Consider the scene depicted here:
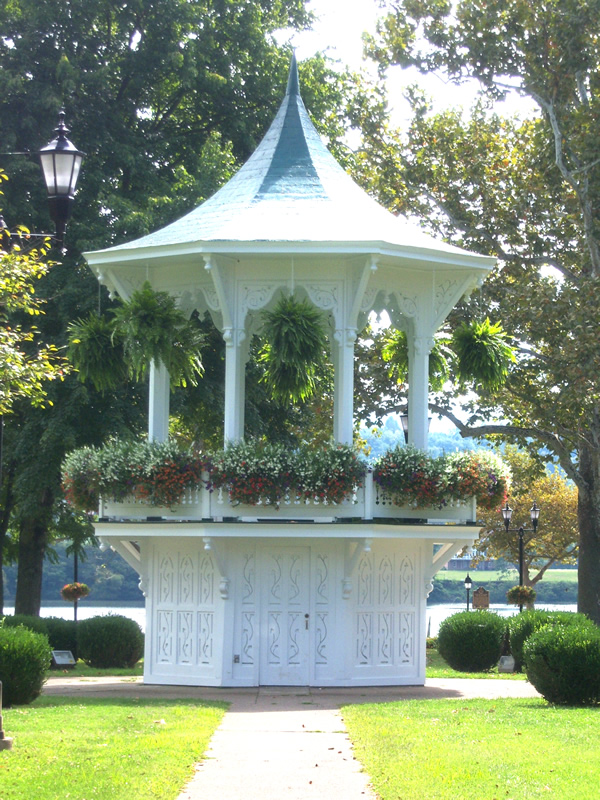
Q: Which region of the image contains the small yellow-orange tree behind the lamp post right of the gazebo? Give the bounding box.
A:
[474,446,578,586]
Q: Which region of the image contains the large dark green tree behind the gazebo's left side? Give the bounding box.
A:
[0,0,370,614]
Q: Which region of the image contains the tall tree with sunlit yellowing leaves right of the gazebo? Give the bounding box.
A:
[358,0,600,623]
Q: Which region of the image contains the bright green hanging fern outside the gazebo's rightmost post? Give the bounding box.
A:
[452,318,516,391]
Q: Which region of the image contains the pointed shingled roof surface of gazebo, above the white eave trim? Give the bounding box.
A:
[88,56,482,255]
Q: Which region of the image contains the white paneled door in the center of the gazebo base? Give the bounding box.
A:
[260,545,312,686]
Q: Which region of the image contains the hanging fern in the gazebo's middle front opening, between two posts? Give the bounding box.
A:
[258,296,327,403]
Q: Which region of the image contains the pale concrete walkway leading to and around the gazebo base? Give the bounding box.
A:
[44,677,538,800]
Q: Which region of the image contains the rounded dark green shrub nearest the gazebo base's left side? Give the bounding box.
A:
[77,614,144,668]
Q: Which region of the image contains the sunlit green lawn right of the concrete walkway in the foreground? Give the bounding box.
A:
[342,699,600,800]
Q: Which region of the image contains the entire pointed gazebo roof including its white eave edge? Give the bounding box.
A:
[85,57,495,273]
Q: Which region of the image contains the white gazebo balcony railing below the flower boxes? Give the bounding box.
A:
[99,472,475,523]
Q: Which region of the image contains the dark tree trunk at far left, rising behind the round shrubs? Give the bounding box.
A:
[15,514,48,617]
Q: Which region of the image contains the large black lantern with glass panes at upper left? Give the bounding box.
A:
[38,109,85,244]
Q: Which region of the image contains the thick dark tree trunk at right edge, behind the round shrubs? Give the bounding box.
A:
[577,448,600,625]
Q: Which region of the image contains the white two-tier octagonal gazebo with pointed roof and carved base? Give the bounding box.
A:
[86,54,495,686]
